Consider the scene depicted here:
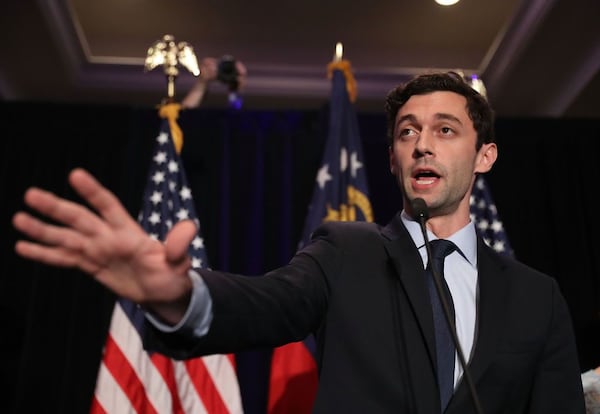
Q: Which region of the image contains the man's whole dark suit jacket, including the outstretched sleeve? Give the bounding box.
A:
[146,216,585,414]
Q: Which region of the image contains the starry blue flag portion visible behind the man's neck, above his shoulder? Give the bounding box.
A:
[469,175,514,256]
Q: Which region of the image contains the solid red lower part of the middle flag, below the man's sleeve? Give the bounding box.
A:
[268,342,318,414]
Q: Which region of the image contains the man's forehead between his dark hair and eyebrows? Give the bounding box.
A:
[396,91,469,123]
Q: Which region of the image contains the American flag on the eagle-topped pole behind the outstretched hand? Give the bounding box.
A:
[90,104,243,414]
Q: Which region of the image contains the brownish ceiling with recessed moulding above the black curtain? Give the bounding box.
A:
[0,0,600,117]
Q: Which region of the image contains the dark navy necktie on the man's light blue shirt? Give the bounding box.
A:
[426,239,457,412]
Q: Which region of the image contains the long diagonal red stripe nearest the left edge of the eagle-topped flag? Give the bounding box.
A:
[104,335,156,414]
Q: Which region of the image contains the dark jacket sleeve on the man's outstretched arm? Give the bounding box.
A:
[144,233,339,359]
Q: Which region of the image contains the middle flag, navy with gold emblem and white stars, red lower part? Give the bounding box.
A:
[268,60,373,414]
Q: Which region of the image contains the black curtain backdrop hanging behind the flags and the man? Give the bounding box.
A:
[0,103,600,414]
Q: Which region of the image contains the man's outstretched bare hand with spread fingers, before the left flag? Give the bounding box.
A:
[13,169,196,324]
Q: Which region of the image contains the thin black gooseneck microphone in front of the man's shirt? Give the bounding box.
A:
[410,197,483,414]
